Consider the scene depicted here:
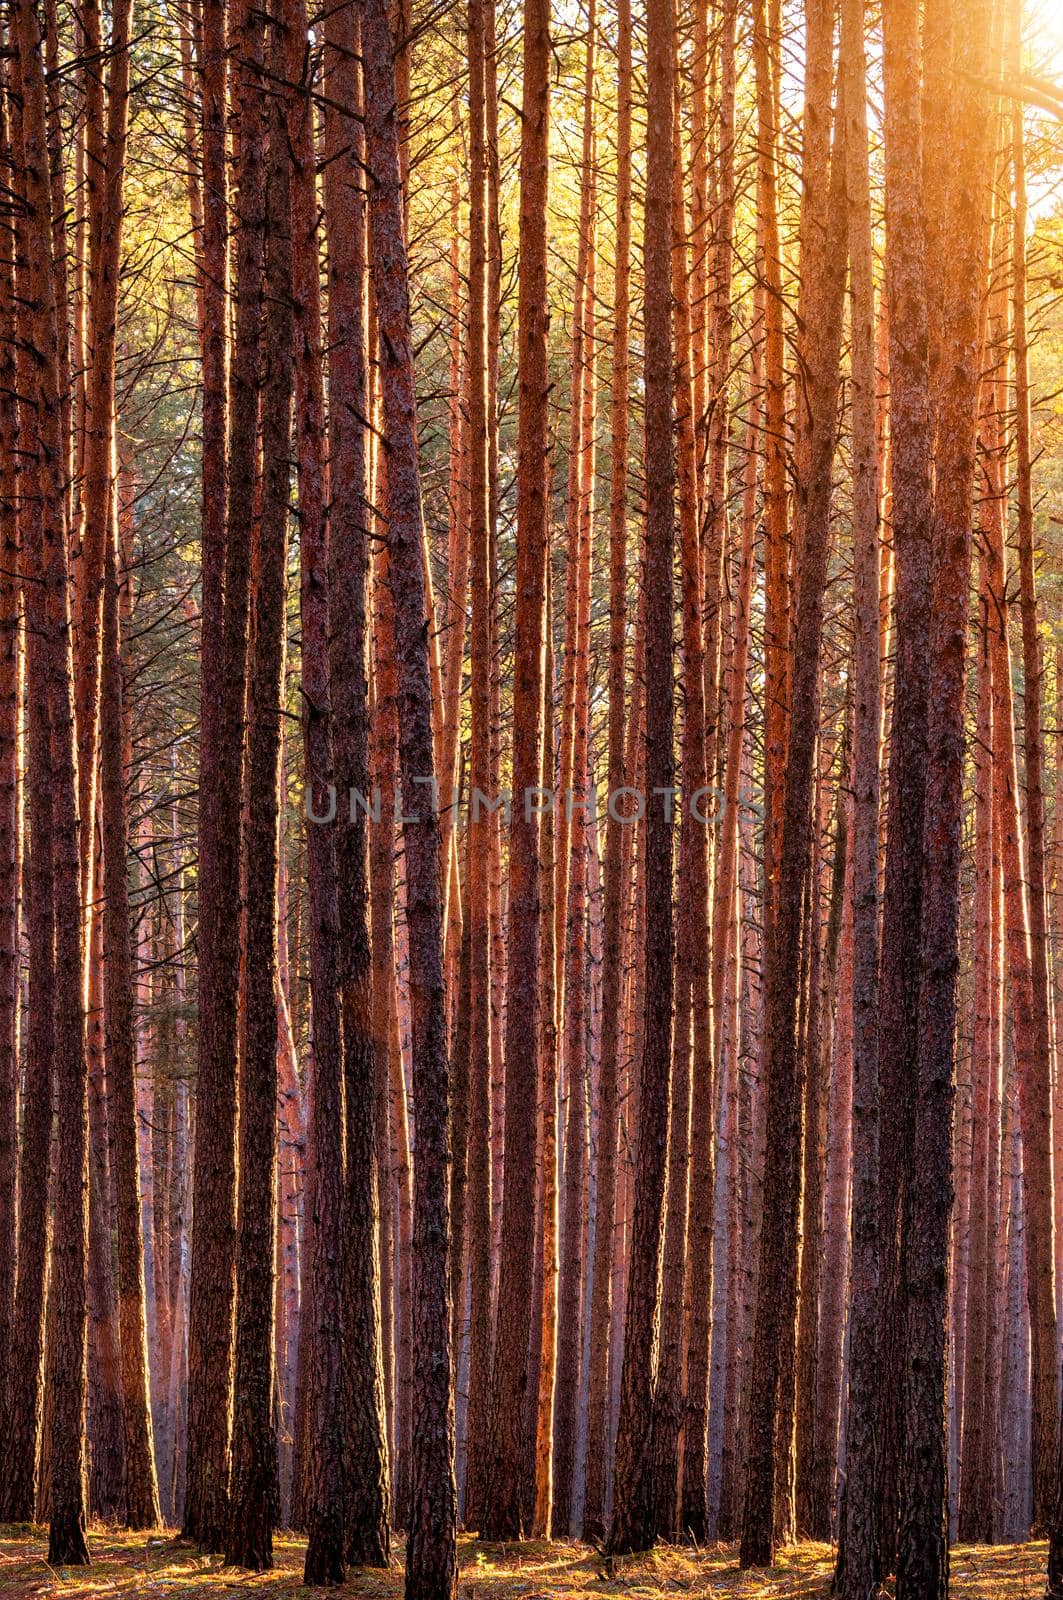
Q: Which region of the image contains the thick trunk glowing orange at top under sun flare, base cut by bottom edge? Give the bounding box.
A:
[890,0,988,1600]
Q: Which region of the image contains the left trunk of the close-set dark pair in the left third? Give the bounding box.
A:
[184,0,266,1550]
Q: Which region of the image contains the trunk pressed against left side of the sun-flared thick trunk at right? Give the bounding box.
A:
[877,0,932,1573]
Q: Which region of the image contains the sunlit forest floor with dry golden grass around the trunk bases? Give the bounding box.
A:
[0,1526,1047,1600]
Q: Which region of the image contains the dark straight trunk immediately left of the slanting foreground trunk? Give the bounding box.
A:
[325,5,394,1566]
